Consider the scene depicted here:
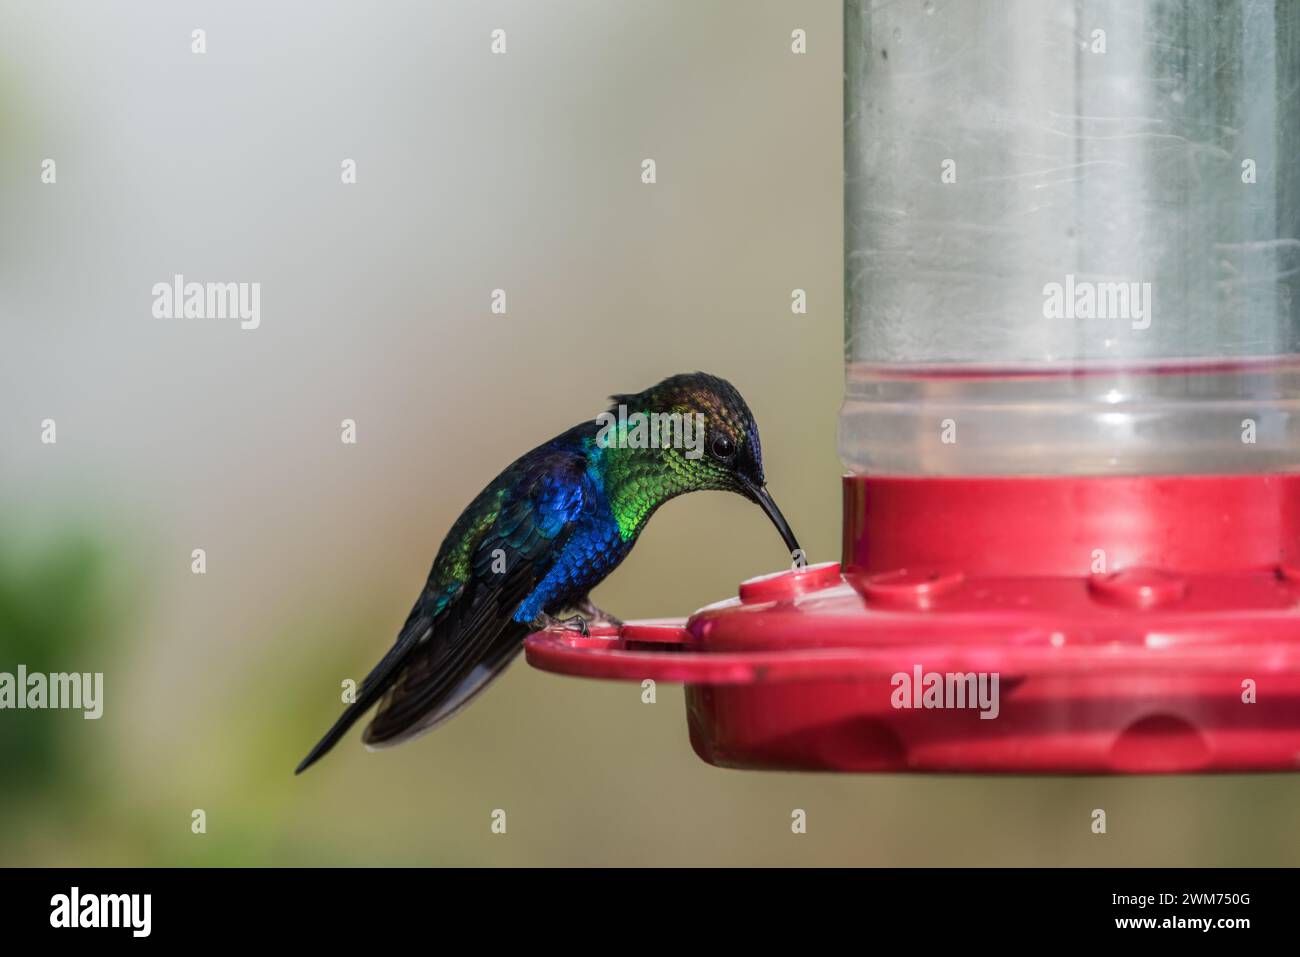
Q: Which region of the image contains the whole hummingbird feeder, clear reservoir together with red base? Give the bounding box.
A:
[527,0,1300,772]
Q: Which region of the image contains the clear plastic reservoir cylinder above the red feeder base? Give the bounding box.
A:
[841,0,1300,475]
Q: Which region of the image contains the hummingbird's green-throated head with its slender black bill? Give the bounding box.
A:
[607,372,800,554]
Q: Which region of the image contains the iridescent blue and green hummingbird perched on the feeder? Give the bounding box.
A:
[295,372,802,774]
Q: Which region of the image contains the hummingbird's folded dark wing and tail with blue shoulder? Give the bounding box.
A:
[299,446,592,771]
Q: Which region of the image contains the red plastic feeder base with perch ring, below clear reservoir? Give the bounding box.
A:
[525,475,1300,774]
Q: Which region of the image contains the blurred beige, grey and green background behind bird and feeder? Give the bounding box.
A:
[0,0,1300,865]
